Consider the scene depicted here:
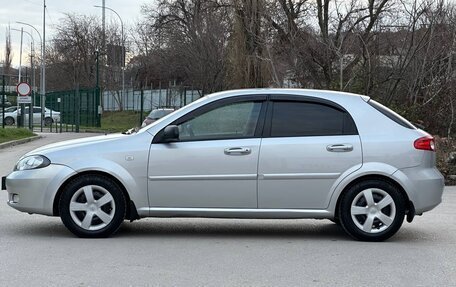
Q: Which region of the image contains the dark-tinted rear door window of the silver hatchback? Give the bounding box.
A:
[271,101,357,137]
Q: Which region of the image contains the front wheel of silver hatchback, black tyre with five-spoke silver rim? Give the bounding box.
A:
[59,175,126,238]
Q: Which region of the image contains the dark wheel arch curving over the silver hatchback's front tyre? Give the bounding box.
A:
[52,170,140,221]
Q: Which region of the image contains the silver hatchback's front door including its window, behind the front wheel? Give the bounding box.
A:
[148,96,265,208]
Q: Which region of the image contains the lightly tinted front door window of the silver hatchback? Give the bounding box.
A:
[178,101,262,141]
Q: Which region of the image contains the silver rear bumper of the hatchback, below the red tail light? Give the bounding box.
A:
[392,167,445,214]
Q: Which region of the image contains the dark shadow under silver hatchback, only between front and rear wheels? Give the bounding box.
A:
[115,218,352,241]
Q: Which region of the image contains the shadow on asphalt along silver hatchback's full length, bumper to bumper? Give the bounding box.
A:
[8,218,436,243]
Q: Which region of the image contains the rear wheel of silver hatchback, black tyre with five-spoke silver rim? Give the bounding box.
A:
[339,180,406,241]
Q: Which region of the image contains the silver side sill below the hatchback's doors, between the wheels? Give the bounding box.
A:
[138,207,333,219]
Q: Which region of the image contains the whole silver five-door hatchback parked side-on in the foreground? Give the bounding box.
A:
[4,89,444,241]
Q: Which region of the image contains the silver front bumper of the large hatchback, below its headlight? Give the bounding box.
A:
[5,164,76,215]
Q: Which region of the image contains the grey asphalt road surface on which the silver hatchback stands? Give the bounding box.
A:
[0,133,456,286]
